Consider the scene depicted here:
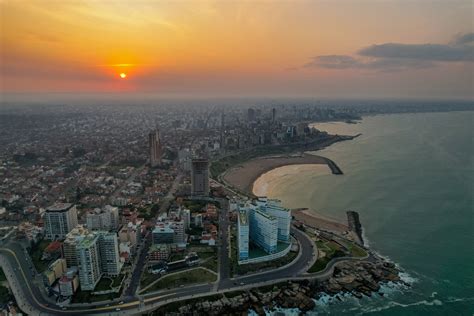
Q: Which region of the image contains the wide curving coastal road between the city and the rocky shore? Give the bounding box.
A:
[0,223,362,315]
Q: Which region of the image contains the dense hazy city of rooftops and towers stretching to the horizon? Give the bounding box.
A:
[0,98,465,314]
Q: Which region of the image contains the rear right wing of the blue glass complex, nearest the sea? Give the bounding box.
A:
[256,197,291,242]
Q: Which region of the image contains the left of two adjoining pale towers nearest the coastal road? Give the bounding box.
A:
[76,234,102,291]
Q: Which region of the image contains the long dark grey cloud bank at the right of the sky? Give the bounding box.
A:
[303,33,474,71]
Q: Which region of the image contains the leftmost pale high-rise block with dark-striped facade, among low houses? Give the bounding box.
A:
[44,203,77,240]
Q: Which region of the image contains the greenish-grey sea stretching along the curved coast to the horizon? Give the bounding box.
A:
[255,112,474,315]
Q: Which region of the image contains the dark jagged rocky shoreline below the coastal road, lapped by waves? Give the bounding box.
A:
[154,257,409,315]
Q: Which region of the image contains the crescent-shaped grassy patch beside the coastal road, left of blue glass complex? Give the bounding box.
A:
[147,268,217,292]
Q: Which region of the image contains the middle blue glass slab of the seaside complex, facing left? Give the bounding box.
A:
[249,207,278,253]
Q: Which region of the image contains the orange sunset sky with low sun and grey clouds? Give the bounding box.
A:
[0,0,474,99]
